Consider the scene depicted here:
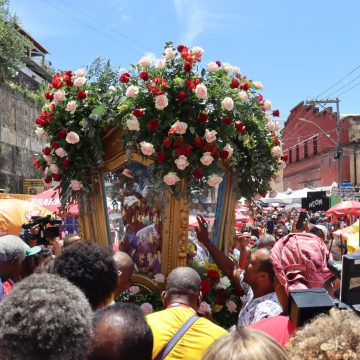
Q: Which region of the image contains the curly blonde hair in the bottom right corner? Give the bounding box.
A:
[286,309,360,360]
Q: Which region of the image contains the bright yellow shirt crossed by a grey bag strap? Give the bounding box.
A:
[146,306,227,360]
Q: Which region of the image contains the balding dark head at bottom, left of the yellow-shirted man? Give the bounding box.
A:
[89,303,153,360]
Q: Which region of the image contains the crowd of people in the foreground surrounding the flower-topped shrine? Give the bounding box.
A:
[0,205,360,360]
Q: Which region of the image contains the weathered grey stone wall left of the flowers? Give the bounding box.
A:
[0,84,42,193]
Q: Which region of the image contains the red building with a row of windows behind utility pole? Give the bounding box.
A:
[282,102,360,190]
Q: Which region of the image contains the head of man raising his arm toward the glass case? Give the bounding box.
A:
[244,248,275,295]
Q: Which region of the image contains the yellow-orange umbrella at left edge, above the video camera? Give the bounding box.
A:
[0,198,52,236]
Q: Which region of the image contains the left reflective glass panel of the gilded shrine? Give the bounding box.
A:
[104,162,162,275]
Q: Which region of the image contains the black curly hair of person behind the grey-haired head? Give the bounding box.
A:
[54,242,118,309]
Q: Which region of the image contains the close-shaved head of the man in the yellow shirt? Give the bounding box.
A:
[162,267,202,310]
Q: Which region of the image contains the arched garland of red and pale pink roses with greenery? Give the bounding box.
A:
[34,43,285,210]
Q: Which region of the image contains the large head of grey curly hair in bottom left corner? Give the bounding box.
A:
[0,273,92,360]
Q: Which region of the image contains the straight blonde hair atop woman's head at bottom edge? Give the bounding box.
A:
[203,328,289,360]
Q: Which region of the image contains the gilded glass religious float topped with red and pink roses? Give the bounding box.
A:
[34,43,285,326]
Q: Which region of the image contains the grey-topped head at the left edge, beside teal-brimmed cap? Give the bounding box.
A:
[0,235,25,281]
